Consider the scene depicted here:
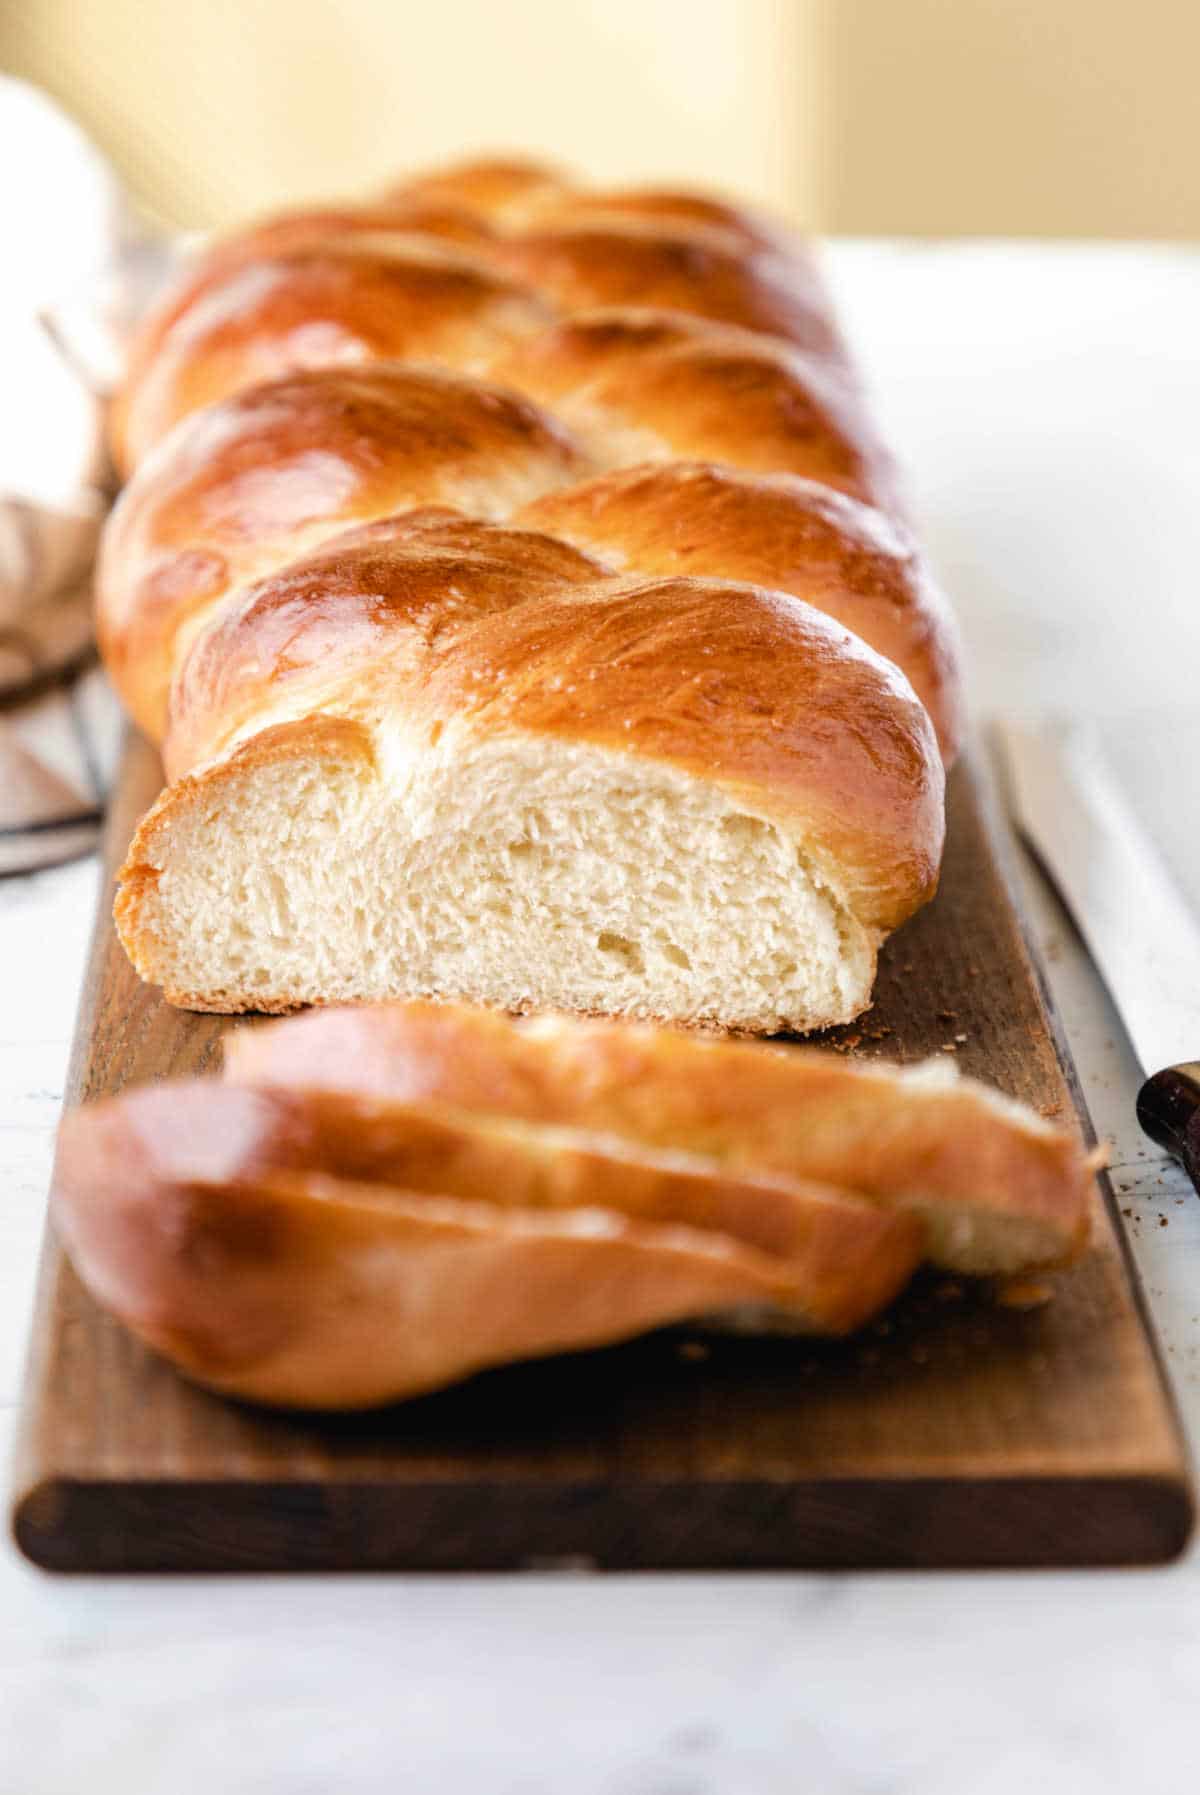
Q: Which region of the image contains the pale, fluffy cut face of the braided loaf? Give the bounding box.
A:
[115,718,879,1032]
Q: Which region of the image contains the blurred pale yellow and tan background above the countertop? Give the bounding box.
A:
[0,0,1200,237]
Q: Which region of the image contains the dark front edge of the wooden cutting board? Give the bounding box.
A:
[13,1475,1193,1572]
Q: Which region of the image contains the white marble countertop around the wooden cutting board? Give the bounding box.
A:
[0,244,1200,1795]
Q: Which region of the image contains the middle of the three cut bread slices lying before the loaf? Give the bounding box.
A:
[56,1079,922,1332]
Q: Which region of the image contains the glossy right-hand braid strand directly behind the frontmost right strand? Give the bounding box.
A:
[515,461,963,766]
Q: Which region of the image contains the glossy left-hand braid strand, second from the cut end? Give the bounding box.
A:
[97,366,587,738]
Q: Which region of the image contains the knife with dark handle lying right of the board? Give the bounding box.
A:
[1001,723,1200,1192]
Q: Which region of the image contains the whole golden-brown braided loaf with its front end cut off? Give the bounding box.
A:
[99,163,961,1030]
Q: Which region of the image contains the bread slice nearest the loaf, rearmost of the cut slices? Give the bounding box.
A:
[226,1003,1096,1274]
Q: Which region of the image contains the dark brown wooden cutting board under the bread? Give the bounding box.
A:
[13,743,1193,1571]
